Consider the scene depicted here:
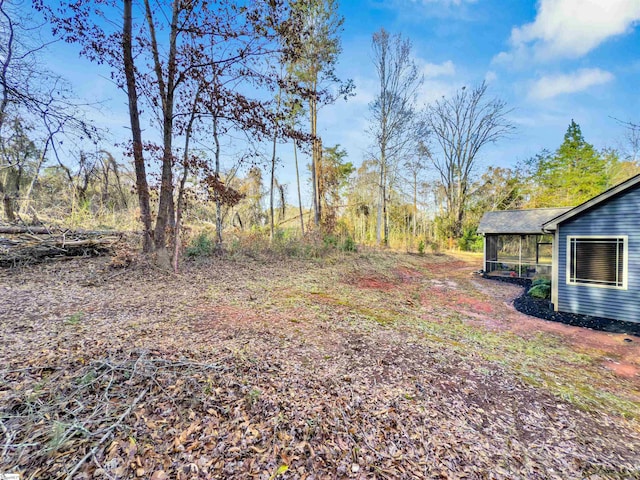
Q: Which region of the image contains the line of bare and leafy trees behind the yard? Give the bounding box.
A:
[0,0,638,265]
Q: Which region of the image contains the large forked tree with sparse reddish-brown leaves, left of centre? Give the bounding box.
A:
[42,0,298,266]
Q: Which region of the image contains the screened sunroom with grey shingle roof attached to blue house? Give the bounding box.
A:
[478,208,570,278]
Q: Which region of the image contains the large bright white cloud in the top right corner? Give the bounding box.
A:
[494,0,640,62]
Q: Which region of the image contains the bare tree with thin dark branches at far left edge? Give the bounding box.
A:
[0,0,100,221]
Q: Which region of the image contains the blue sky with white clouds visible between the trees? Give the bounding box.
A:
[31,0,640,202]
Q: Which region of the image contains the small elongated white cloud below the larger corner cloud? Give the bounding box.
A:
[529,68,614,100]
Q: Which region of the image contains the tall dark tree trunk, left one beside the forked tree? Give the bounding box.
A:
[122,0,153,253]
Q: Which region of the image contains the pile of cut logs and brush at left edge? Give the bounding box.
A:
[0,225,123,267]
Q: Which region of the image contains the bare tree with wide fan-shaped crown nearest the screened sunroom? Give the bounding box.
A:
[425,82,515,242]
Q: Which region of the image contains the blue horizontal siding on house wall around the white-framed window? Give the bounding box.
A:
[556,187,640,322]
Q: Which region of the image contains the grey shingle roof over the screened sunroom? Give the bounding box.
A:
[478,207,572,235]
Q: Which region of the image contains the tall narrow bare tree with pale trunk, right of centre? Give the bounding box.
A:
[369,29,423,244]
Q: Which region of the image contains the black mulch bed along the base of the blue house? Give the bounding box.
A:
[484,275,640,340]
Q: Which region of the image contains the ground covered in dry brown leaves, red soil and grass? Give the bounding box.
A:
[0,252,640,480]
